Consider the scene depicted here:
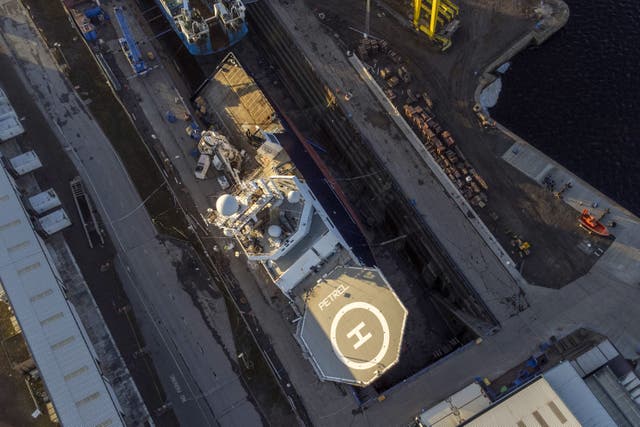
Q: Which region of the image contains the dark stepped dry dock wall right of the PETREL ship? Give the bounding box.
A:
[249,2,498,334]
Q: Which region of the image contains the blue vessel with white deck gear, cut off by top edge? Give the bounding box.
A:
[155,0,248,55]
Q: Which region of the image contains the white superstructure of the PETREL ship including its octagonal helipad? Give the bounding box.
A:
[210,171,407,386]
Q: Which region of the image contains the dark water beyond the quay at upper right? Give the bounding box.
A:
[491,0,640,215]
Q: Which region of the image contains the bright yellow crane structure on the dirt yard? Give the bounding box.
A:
[413,0,460,51]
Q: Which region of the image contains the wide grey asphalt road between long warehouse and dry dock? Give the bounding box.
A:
[0,0,262,426]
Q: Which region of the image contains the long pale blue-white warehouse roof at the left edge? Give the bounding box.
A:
[0,168,124,426]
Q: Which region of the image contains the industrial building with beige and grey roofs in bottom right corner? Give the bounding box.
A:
[416,340,640,427]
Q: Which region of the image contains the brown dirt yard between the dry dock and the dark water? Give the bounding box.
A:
[307,0,611,288]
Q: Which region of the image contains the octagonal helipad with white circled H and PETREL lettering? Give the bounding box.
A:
[300,266,407,386]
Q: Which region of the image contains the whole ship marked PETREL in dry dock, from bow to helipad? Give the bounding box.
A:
[185,54,409,389]
